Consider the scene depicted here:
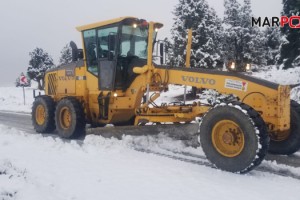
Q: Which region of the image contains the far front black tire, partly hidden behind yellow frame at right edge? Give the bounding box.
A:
[269,100,300,155]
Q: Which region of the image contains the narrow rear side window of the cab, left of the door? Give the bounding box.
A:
[83,29,98,75]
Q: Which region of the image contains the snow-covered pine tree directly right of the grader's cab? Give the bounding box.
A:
[171,0,222,68]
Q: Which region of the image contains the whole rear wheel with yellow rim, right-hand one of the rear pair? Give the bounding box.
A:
[55,98,86,139]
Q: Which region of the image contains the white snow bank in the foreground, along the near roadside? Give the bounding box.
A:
[0,125,300,200]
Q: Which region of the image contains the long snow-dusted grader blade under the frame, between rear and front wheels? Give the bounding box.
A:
[87,123,199,144]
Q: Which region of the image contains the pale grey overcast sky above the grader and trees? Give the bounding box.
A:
[0,0,282,86]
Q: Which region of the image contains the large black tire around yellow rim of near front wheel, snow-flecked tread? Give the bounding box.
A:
[200,102,270,173]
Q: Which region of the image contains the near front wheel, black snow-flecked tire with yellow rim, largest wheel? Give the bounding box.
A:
[200,102,269,173]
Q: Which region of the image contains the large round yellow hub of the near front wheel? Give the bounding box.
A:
[212,120,245,157]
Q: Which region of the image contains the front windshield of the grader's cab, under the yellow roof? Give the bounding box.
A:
[120,25,156,59]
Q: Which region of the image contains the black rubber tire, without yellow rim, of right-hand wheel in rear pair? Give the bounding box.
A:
[55,97,86,139]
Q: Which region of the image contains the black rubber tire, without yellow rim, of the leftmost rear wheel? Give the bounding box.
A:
[31,96,55,133]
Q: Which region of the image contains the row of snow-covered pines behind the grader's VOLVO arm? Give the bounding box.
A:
[166,0,300,69]
